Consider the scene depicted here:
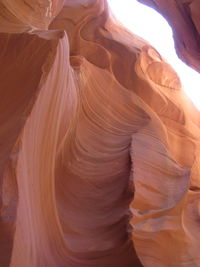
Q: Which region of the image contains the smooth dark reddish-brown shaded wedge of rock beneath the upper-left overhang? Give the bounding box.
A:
[0,29,59,197]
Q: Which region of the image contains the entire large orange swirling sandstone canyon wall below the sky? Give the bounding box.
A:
[0,0,200,267]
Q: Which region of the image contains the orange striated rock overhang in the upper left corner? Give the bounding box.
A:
[0,0,64,33]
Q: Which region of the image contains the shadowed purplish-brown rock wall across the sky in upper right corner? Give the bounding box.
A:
[137,0,200,72]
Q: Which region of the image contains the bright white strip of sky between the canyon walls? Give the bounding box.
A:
[108,0,200,110]
